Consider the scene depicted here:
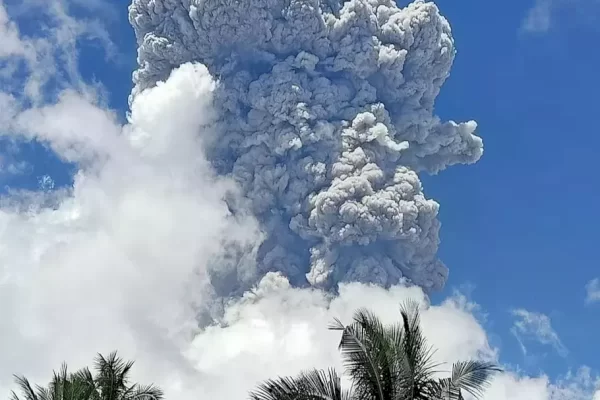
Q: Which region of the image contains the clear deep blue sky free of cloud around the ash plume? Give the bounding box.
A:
[1,0,600,398]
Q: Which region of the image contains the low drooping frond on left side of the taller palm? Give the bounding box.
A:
[250,369,349,400]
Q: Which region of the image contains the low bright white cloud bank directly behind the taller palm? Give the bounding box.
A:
[177,276,576,400]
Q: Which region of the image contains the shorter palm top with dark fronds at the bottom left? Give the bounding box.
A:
[11,352,163,400]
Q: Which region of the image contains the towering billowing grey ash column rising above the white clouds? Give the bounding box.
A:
[129,0,483,293]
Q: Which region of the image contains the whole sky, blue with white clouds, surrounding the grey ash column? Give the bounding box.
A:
[0,0,600,400]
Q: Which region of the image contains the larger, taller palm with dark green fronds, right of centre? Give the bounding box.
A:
[250,301,500,400]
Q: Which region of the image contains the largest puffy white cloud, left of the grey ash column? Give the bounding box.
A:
[0,61,258,396]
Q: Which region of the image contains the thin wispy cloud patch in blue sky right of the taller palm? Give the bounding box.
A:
[511,309,568,356]
